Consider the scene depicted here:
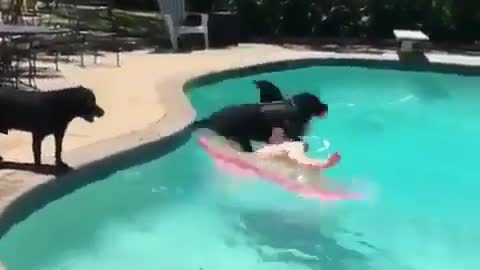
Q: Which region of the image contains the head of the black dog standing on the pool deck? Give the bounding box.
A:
[73,86,105,122]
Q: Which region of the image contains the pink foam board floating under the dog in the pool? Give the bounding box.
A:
[199,135,363,201]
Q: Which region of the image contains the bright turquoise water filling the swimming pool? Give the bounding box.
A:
[0,66,480,270]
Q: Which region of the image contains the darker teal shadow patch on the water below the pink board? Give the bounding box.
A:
[232,210,369,270]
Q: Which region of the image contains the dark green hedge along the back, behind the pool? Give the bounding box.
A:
[111,0,480,42]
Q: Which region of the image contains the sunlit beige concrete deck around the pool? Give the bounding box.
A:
[0,44,480,269]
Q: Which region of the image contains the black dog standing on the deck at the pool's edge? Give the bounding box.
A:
[0,86,104,166]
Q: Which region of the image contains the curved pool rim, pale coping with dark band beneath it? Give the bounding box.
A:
[0,48,480,269]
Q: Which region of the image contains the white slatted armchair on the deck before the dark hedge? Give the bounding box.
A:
[157,0,209,50]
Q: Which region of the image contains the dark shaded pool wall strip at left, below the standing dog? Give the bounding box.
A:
[0,126,192,238]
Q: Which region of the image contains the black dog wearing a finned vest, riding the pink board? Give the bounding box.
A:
[194,81,328,152]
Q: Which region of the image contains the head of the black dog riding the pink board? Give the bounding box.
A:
[292,93,328,120]
